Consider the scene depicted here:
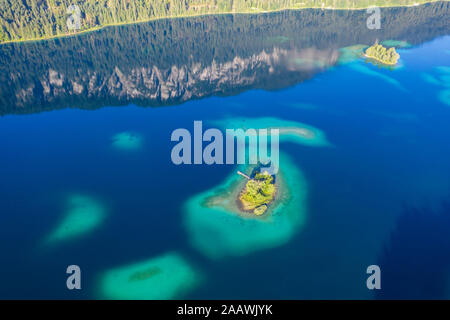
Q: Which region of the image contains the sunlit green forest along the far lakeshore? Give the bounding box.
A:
[0,0,437,42]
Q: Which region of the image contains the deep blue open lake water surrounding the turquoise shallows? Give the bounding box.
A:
[0,12,450,299]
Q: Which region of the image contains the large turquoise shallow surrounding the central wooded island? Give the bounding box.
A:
[183,154,307,259]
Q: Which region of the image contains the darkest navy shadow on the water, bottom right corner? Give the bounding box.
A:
[376,200,450,299]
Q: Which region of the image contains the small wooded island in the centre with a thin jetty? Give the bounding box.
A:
[238,171,276,216]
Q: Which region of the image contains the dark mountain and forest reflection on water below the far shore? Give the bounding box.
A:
[0,2,449,115]
